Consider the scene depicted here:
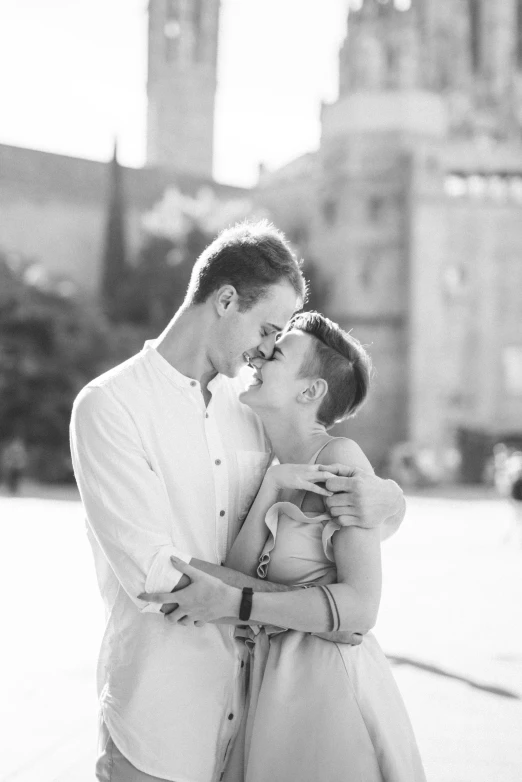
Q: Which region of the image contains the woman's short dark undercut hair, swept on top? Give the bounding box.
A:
[288,312,372,428]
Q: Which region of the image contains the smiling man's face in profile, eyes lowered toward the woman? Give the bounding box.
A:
[215,282,301,377]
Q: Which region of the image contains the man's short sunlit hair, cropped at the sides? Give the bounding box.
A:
[186,220,307,312]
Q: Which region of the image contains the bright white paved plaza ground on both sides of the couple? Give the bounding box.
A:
[0,487,522,782]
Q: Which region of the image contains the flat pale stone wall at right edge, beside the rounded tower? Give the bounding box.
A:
[410,149,522,447]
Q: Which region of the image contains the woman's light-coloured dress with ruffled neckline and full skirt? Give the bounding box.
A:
[230,454,425,782]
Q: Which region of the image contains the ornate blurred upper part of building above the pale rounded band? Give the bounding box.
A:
[340,0,522,139]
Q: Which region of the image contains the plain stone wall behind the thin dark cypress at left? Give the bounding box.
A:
[0,145,245,295]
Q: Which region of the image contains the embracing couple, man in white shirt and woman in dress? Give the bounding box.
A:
[71,222,425,782]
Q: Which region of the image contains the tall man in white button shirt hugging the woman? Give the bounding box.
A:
[71,222,404,782]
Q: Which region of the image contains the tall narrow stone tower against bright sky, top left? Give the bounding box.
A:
[147,0,219,178]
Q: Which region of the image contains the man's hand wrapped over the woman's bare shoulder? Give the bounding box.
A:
[325,464,404,528]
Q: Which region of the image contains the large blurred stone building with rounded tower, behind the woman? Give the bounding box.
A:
[257,0,522,464]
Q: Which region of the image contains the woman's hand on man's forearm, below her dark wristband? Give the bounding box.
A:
[138,557,241,627]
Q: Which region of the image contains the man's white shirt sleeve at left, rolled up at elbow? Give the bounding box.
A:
[70,386,191,612]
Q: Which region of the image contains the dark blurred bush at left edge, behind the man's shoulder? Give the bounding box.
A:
[0,258,110,481]
